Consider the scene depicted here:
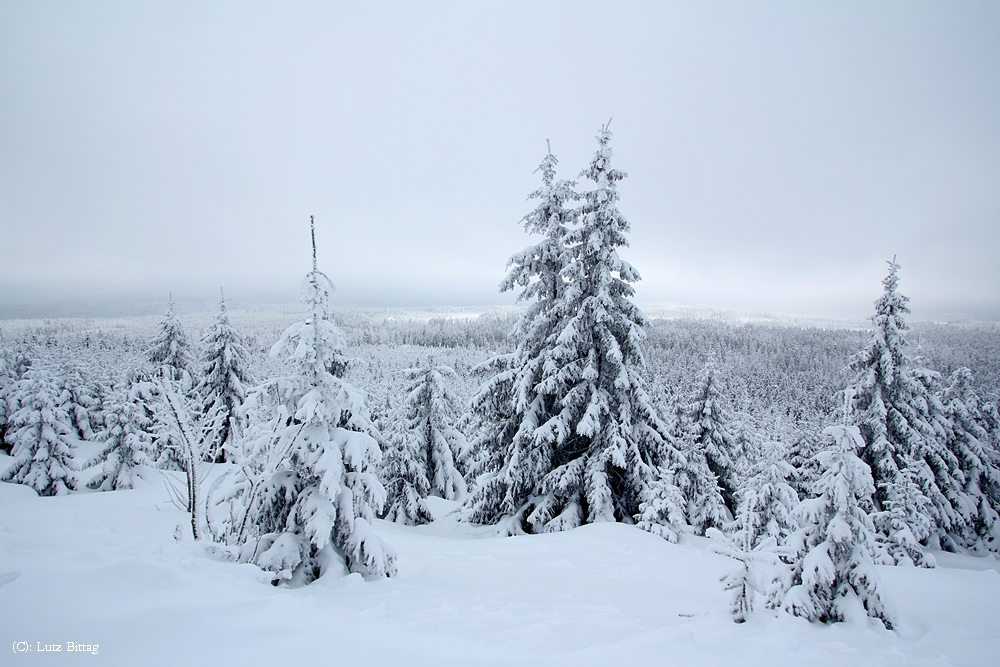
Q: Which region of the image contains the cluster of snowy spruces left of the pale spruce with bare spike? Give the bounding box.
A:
[0,290,252,495]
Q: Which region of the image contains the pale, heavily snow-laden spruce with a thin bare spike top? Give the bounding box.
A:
[210,220,396,583]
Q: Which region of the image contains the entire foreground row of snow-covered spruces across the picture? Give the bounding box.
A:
[0,126,1000,627]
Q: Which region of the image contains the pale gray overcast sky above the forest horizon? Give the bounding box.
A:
[0,0,1000,320]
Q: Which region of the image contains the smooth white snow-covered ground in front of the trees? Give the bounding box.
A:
[0,454,1000,667]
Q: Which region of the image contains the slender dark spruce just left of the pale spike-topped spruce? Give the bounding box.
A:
[197,290,252,463]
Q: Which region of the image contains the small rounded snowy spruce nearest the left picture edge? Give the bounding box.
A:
[3,367,78,496]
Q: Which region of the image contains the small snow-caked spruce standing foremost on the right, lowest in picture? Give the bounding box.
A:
[781,426,896,630]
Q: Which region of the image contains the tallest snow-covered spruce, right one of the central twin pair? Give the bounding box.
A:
[469,126,684,539]
